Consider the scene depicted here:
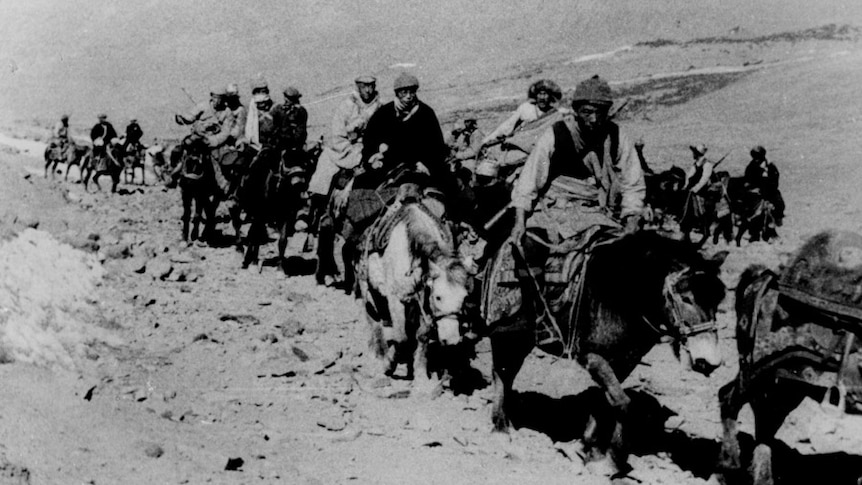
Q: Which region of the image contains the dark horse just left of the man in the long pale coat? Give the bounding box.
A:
[238,148,309,272]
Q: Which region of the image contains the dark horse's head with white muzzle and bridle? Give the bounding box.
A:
[663,251,727,375]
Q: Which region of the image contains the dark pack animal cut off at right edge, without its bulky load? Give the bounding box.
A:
[717,246,862,485]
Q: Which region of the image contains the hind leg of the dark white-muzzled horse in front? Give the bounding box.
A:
[490,313,536,432]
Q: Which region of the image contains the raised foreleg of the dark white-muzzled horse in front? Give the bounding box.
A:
[584,353,631,475]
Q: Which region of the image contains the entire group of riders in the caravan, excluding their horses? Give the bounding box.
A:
[45,73,784,292]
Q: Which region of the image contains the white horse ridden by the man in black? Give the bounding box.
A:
[357,194,480,393]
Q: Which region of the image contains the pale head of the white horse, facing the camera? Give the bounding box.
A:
[423,257,470,345]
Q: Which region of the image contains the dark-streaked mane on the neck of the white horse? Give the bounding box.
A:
[404,203,468,285]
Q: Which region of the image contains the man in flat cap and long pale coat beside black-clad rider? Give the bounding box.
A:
[308,75,382,283]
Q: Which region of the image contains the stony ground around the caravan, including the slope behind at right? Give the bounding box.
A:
[0,15,862,484]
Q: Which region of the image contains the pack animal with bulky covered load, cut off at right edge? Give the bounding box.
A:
[718,231,862,485]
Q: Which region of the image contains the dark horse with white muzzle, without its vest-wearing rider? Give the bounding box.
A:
[483,231,727,470]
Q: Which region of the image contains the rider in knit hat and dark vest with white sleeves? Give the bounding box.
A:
[512,76,646,243]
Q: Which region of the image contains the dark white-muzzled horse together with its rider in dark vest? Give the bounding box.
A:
[481,76,726,476]
